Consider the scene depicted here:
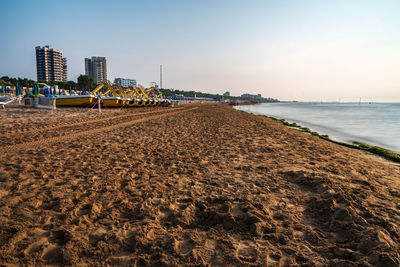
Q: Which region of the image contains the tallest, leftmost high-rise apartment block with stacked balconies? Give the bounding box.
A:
[36,45,67,82]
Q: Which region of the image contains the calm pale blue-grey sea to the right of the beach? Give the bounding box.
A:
[236,102,400,152]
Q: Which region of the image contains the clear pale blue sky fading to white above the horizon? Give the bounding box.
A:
[0,0,400,101]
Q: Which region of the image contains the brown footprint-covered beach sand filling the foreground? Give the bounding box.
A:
[0,105,400,266]
